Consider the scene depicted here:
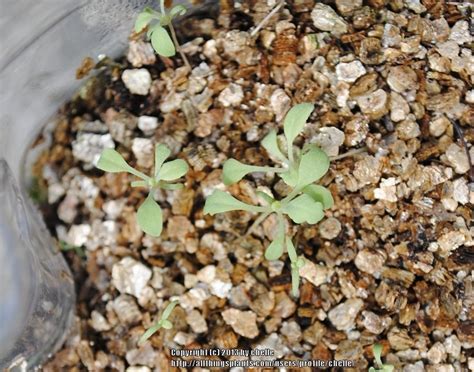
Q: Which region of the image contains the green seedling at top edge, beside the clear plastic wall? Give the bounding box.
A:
[135,0,191,68]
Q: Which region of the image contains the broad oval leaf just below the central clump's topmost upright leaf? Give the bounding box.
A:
[296,146,329,188]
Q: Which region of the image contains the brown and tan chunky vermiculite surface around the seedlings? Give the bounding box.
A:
[32,0,474,372]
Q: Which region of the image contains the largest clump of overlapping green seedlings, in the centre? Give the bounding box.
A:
[204,103,334,296]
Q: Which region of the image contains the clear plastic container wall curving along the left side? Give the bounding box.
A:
[0,0,216,370]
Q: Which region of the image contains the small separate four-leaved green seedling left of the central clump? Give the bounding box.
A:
[97,144,189,237]
